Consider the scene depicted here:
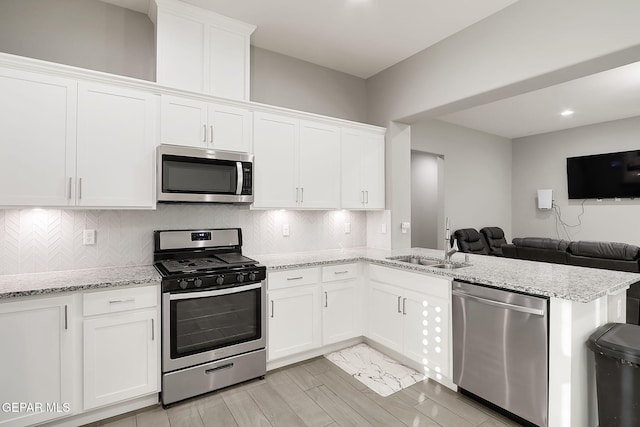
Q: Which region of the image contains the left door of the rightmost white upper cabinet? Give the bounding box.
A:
[340,129,365,209]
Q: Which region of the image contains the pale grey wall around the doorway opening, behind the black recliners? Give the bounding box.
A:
[411,120,512,242]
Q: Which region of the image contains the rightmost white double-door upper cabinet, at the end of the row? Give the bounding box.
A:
[341,128,385,209]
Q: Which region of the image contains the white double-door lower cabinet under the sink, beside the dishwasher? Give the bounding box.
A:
[367,265,451,379]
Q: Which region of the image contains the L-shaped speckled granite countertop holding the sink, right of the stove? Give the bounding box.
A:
[250,248,640,302]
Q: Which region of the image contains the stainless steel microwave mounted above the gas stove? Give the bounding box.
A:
[156,145,253,203]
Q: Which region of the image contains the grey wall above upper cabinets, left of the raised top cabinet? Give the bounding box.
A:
[0,0,156,81]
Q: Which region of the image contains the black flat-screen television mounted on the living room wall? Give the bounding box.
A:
[567,150,640,199]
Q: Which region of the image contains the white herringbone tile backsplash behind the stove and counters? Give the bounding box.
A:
[0,204,379,275]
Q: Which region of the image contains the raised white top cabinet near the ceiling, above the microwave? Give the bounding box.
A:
[155,0,255,100]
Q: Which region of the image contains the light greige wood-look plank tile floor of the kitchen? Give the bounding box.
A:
[86,357,519,427]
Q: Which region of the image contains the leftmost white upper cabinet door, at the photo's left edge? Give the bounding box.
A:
[0,69,77,206]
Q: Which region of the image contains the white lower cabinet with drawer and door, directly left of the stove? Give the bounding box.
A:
[83,286,160,410]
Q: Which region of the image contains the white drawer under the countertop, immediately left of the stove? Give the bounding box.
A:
[82,286,159,316]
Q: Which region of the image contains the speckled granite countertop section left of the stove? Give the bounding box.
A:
[0,265,161,300]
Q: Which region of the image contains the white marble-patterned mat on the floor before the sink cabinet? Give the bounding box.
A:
[325,343,425,397]
